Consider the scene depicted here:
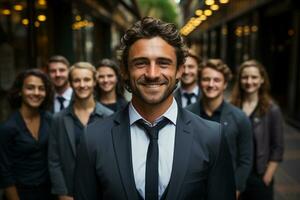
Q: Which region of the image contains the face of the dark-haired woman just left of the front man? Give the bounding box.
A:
[97,67,118,93]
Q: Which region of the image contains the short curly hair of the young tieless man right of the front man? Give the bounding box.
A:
[199,58,232,83]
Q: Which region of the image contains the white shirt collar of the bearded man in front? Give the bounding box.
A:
[129,98,178,125]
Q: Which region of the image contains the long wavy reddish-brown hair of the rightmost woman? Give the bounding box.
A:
[231,60,272,115]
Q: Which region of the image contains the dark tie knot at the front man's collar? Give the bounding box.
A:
[136,118,169,140]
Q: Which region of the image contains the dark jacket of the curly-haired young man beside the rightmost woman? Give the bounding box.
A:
[186,101,253,191]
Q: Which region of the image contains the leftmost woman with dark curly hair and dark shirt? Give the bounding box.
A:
[0,69,53,200]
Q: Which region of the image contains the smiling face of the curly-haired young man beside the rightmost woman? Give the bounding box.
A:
[200,67,227,99]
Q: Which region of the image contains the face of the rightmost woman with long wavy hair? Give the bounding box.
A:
[240,66,264,94]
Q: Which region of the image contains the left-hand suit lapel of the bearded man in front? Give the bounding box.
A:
[112,106,138,200]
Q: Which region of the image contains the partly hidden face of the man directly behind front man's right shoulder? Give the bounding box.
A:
[181,56,198,89]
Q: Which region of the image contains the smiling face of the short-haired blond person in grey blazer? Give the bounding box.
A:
[71,68,96,99]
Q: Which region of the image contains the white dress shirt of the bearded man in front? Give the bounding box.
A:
[129,99,178,199]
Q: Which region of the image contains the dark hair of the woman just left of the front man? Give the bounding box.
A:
[96,58,124,98]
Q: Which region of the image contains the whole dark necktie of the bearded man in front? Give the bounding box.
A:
[137,118,169,200]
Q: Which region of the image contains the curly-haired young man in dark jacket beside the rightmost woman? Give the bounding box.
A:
[187,59,253,197]
